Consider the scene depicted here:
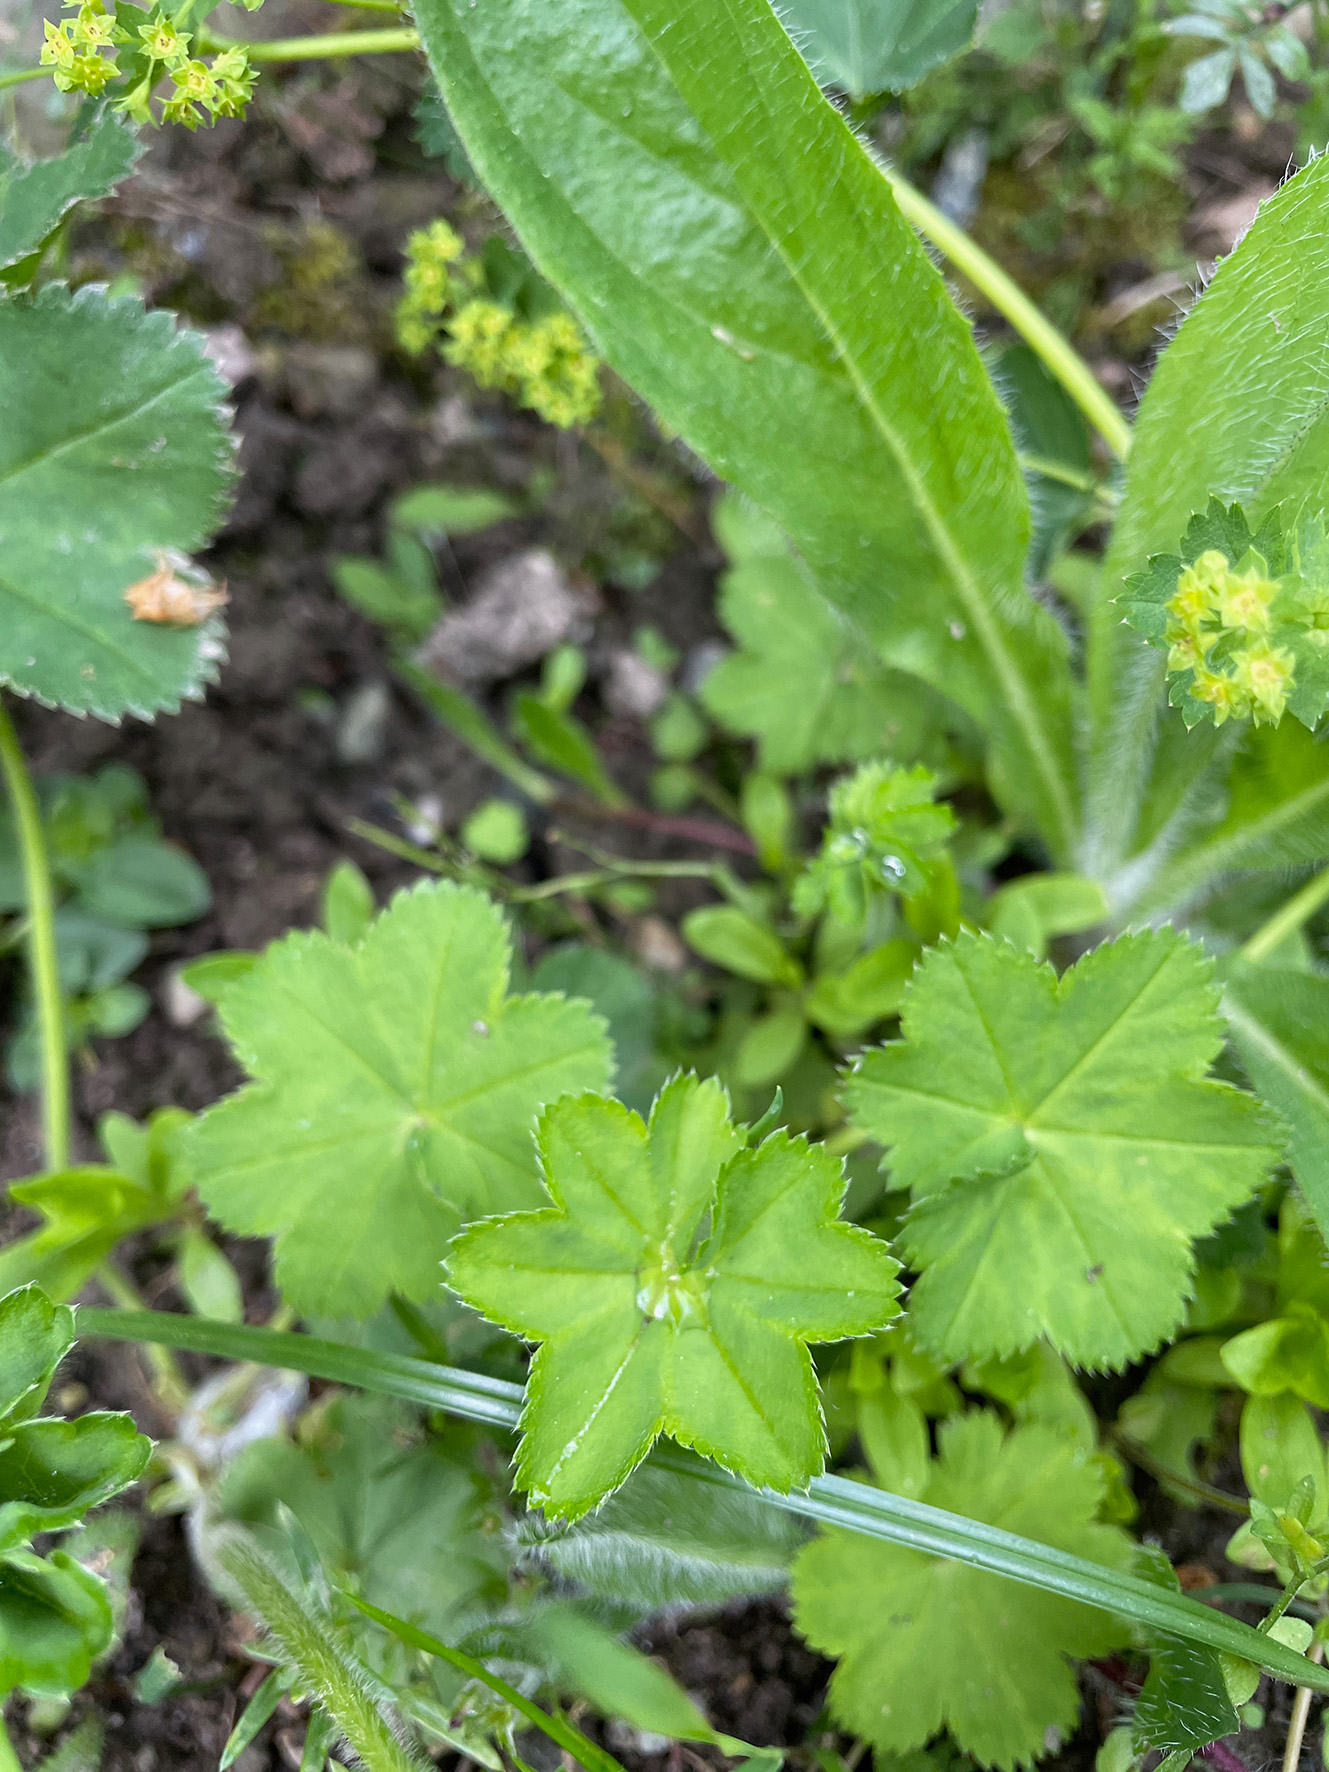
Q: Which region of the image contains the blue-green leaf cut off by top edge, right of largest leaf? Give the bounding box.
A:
[781,0,978,99]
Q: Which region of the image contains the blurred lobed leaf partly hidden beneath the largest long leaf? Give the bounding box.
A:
[698,493,943,774]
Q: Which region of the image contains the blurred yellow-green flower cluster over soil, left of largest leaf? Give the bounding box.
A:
[397,222,601,429]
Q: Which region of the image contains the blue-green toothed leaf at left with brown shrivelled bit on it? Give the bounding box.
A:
[0,284,232,719]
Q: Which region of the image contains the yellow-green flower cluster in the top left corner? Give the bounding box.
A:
[41,0,255,129]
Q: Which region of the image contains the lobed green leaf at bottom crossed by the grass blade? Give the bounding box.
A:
[792,1412,1131,1768]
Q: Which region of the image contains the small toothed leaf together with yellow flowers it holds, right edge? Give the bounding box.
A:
[1118,498,1329,728]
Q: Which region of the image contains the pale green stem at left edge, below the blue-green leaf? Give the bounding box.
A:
[0,703,69,1170]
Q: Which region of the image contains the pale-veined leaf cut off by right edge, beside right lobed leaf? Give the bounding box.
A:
[1223,962,1329,1237]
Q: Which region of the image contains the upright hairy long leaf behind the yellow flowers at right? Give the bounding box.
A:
[1088,159,1329,877]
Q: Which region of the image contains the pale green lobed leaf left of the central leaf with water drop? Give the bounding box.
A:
[188,884,611,1317]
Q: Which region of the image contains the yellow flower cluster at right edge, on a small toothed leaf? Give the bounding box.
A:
[1164,548,1295,727]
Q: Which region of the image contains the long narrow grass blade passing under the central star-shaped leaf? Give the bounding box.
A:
[80,1310,1329,1692]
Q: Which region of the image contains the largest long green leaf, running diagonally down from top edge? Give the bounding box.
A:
[416,0,1076,852]
